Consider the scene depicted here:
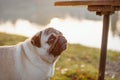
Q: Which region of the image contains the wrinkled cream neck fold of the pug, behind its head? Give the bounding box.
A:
[23,40,58,66]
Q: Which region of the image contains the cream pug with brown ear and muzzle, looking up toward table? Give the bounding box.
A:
[0,28,67,80]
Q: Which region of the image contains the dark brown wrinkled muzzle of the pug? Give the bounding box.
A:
[49,36,67,56]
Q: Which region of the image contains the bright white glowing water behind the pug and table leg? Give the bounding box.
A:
[0,17,120,51]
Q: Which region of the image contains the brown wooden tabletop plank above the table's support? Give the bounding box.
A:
[55,0,120,6]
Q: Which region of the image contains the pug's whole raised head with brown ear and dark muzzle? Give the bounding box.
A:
[31,28,67,57]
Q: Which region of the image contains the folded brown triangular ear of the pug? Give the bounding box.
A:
[31,32,42,48]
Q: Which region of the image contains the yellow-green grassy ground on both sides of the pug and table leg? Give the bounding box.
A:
[0,33,120,80]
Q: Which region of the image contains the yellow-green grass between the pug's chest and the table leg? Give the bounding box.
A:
[52,44,99,80]
